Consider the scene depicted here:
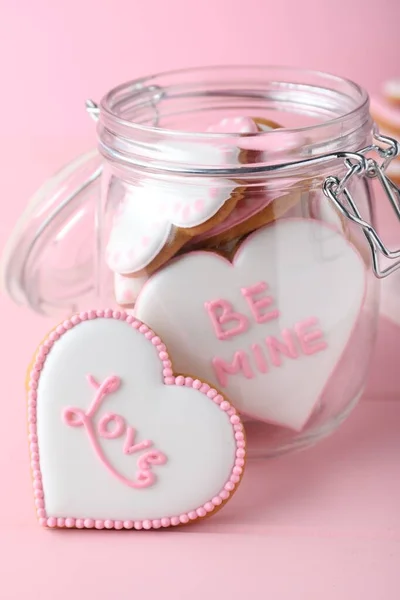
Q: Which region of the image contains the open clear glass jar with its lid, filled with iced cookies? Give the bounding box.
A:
[3,67,398,456]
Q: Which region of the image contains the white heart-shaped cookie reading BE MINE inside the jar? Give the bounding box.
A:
[135,219,366,430]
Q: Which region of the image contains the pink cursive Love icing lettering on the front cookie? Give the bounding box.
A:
[62,375,167,489]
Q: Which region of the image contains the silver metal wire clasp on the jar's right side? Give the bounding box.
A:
[323,131,400,279]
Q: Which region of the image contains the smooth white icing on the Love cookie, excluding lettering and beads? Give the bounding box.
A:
[37,318,236,521]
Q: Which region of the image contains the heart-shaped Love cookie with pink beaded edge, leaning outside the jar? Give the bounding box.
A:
[29,310,245,529]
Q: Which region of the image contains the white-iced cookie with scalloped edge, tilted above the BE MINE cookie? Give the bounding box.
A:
[106,132,247,276]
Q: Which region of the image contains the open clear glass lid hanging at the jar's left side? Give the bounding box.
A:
[1,150,102,316]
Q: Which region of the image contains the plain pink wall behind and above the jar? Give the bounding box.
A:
[0,0,400,136]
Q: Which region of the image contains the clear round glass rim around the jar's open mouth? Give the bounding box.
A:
[98,65,372,175]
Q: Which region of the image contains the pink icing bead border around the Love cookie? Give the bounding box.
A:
[28,309,246,530]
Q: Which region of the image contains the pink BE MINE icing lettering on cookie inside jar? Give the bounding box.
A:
[204,281,327,387]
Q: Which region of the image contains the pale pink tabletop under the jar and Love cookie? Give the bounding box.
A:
[0,138,400,600]
